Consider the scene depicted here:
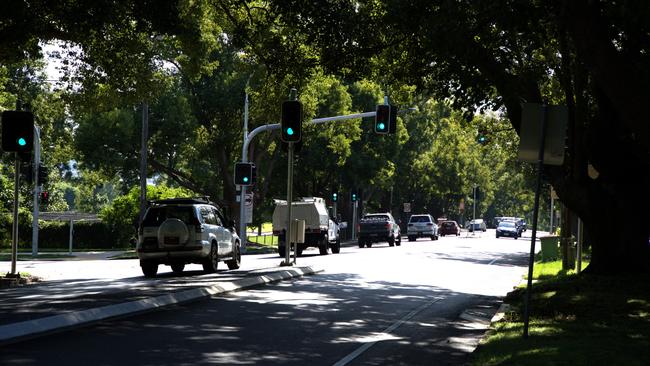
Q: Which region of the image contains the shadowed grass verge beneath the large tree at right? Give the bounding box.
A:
[471,262,650,365]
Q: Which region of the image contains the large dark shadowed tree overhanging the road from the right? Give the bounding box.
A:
[271,0,650,273]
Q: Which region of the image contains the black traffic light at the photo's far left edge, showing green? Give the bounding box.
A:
[2,111,34,152]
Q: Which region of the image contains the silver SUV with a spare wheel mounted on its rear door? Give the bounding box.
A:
[136,198,241,277]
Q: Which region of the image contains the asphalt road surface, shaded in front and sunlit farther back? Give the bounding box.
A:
[0,231,530,365]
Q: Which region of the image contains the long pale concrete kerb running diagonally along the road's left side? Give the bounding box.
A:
[0,267,322,345]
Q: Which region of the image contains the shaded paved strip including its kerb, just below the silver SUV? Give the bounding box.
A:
[0,266,320,345]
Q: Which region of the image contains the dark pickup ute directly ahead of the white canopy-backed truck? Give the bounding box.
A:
[357,212,402,248]
